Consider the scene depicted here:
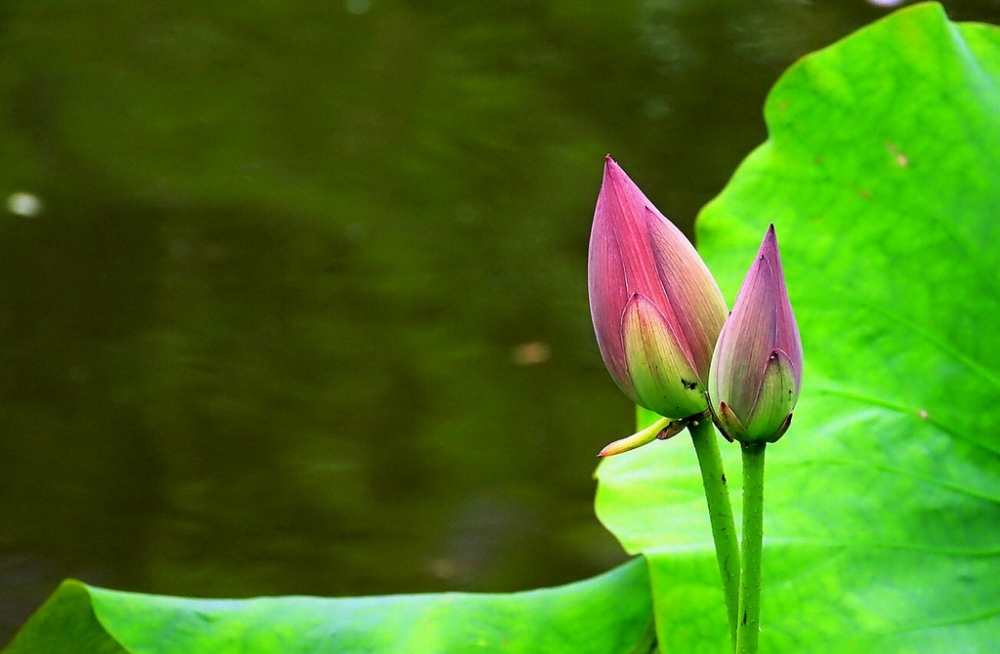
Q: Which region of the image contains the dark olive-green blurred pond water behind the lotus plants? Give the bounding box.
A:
[0,0,1000,643]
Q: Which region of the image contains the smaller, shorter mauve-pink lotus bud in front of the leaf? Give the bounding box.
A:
[709,225,802,443]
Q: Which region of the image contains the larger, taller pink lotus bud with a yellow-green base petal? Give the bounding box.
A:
[588,156,726,418]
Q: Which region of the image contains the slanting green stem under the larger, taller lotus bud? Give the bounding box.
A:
[688,418,740,647]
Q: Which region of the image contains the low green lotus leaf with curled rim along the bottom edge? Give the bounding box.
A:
[5,557,653,654]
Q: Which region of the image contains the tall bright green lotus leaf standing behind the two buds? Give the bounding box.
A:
[597,4,1000,654]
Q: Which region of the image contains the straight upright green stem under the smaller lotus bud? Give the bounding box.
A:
[736,443,767,654]
